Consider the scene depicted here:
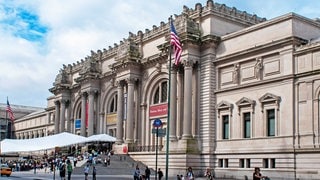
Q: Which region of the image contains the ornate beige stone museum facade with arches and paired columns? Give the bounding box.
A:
[13,0,320,179]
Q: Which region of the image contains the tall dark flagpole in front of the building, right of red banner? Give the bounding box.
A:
[166,16,172,180]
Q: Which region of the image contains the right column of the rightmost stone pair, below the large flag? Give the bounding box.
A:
[182,60,193,139]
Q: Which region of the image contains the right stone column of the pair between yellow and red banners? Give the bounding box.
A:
[126,79,135,143]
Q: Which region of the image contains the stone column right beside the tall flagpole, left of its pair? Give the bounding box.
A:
[169,66,177,141]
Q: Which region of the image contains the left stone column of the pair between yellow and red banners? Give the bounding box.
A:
[116,81,124,144]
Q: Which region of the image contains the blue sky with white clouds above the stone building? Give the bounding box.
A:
[0,0,320,108]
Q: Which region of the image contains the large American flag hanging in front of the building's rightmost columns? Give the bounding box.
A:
[170,20,182,65]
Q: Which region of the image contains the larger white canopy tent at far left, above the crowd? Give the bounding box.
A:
[1,132,89,154]
